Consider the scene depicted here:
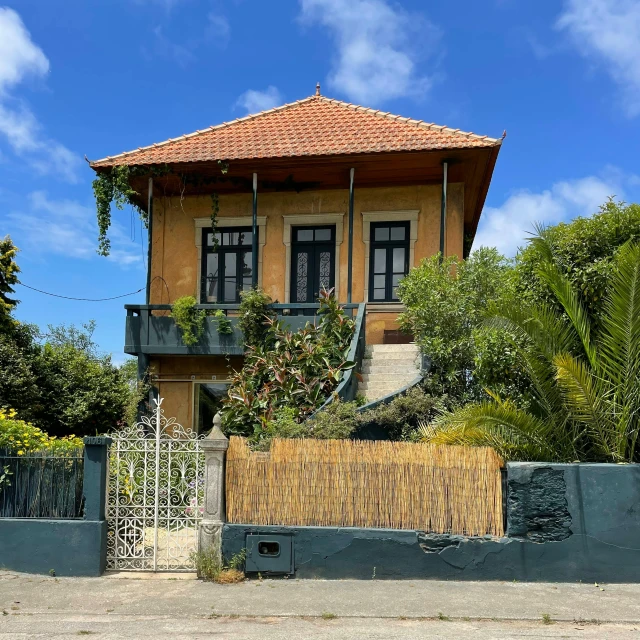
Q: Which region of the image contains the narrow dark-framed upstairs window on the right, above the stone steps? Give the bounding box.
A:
[369,222,409,302]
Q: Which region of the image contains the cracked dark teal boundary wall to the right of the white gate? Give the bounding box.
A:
[222,463,640,582]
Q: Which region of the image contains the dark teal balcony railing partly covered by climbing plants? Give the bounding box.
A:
[124,303,364,355]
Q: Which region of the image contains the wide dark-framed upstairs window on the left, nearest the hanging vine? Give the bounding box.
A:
[200,227,253,304]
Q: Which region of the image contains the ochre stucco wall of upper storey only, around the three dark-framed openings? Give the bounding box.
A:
[151,184,464,312]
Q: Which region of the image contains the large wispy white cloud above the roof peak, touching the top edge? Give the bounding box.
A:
[300,0,440,105]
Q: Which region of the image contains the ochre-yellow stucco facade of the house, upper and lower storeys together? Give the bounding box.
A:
[150,183,464,426]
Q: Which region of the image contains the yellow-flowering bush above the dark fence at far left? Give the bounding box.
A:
[0,408,83,456]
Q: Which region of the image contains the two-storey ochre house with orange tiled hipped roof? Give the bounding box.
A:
[91,86,502,430]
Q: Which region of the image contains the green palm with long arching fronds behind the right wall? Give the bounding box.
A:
[421,238,640,462]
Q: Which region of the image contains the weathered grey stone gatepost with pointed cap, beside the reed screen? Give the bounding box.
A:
[198,413,229,560]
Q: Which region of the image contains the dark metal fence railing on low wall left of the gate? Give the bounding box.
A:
[0,448,84,519]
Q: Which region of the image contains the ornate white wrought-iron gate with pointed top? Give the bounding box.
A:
[107,398,204,571]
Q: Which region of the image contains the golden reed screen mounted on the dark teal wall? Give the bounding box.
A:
[226,437,504,536]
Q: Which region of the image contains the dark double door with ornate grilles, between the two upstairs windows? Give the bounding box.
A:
[290,226,336,312]
